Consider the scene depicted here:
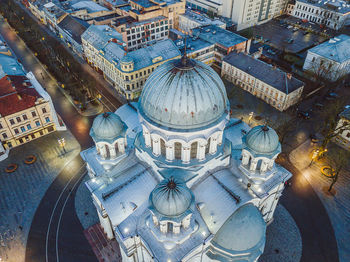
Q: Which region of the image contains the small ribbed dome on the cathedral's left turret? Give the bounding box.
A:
[90,112,126,142]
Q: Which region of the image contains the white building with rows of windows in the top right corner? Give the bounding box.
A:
[293,0,350,30]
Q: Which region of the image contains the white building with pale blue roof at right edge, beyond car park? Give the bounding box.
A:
[303,35,350,81]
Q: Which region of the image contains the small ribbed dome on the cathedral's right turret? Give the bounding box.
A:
[245,126,279,154]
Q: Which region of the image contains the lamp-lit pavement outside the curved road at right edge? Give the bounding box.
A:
[289,140,350,262]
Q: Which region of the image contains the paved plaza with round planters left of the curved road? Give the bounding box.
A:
[0,131,80,262]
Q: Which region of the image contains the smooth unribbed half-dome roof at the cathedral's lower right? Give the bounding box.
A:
[213,204,266,251]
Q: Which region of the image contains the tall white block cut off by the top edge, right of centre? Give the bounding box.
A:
[187,0,287,30]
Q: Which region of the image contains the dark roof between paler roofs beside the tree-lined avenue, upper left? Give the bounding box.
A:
[58,15,89,44]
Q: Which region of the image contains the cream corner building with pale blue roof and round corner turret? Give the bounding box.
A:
[82,25,181,100]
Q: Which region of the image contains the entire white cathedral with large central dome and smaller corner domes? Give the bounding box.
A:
[81,56,291,262]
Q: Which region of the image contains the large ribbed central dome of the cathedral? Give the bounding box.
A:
[140,57,229,129]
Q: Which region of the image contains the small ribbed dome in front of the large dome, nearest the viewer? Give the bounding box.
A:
[150,177,194,216]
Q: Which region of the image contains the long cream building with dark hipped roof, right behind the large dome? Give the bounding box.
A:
[221,52,304,111]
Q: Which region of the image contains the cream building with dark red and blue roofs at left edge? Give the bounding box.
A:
[0,54,65,160]
